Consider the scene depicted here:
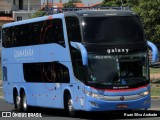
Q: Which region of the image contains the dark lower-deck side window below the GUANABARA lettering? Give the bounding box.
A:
[23,62,70,83]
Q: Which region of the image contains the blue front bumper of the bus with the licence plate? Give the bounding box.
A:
[86,94,151,111]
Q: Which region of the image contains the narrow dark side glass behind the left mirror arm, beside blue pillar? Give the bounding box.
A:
[65,17,85,81]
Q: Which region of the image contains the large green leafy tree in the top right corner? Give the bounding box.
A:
[133,0,160,42]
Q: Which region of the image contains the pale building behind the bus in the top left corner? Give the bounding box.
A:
[0,0,41,21]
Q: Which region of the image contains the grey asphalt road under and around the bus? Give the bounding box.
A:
[0,98,160,120]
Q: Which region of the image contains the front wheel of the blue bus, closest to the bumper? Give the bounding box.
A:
[67,95,76,117]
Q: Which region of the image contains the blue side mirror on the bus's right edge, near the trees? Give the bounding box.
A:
[147,41,158,63]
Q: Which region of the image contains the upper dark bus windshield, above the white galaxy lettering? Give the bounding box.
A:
[82,16,145,45]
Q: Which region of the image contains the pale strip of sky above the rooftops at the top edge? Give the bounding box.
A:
[41,0,103,5]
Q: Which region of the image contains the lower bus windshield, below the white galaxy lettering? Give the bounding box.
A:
[87,52,149,86]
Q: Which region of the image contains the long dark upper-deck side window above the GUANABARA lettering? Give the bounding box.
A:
[2,19,65,48]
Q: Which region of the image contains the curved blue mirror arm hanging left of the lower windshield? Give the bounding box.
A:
[70,42,88,66]
